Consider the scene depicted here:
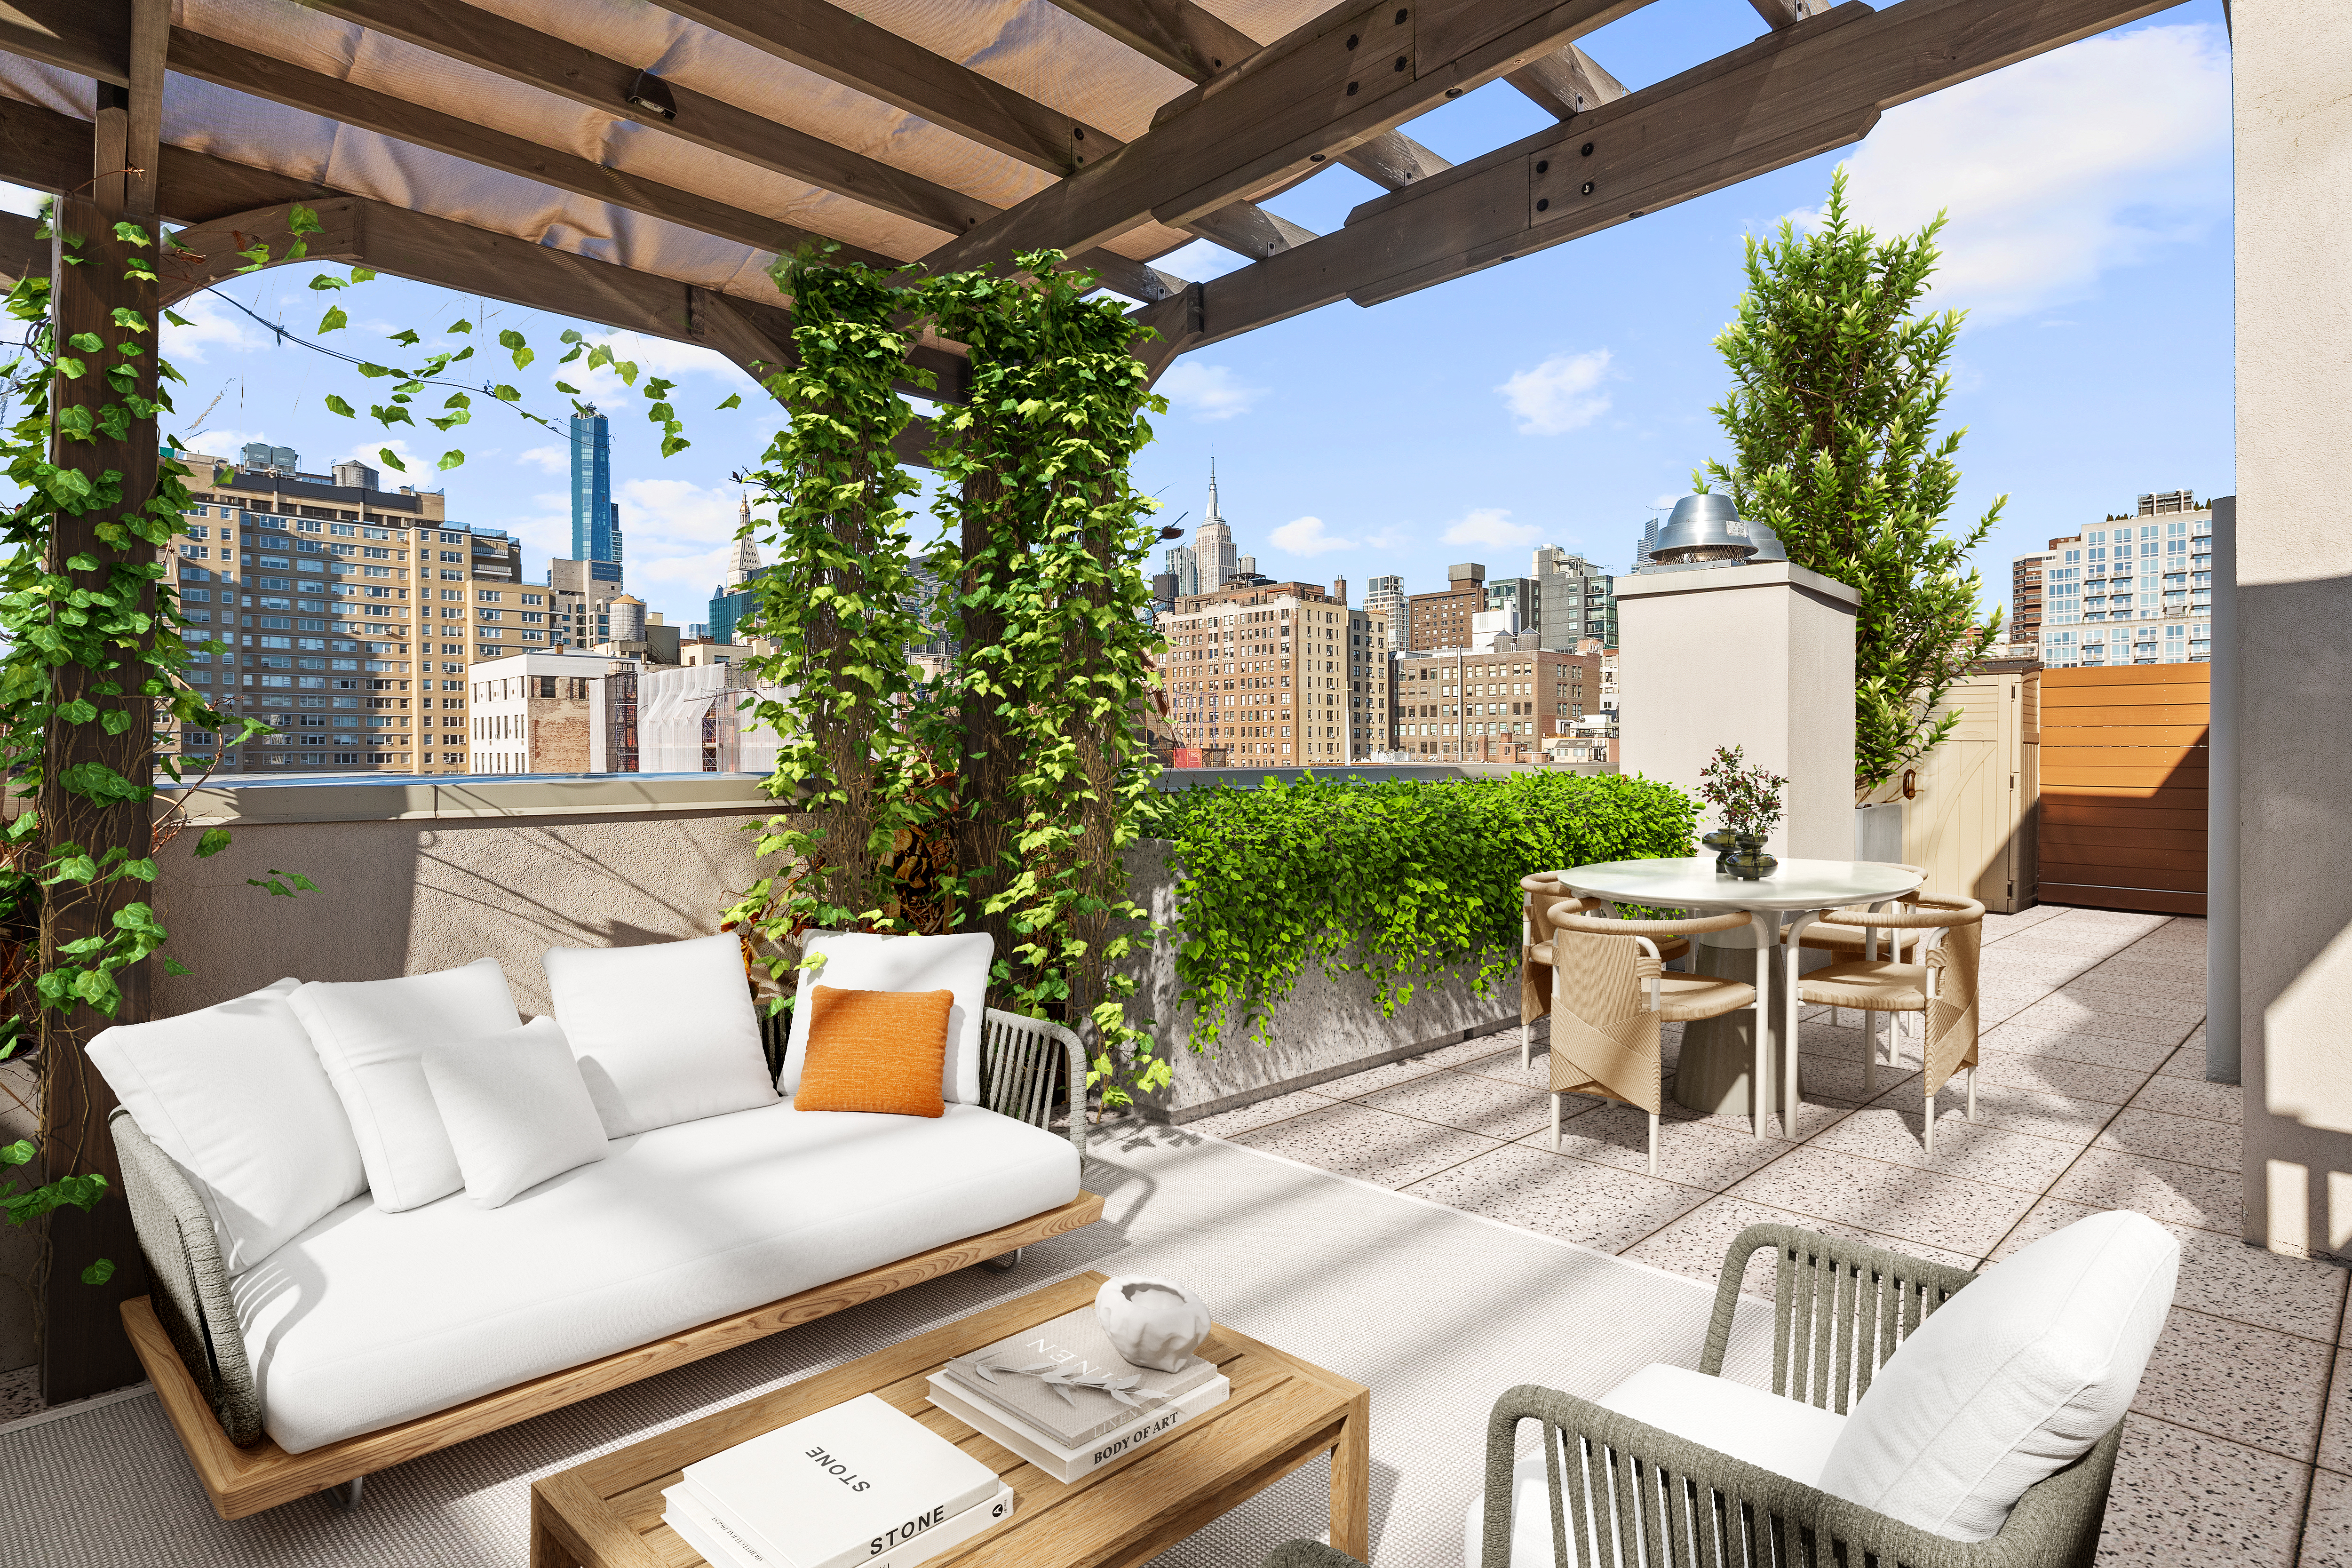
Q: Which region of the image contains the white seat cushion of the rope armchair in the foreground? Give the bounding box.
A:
[1463,1363,1846,1568]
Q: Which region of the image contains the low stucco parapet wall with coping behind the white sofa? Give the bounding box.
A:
[155,776,769,1016]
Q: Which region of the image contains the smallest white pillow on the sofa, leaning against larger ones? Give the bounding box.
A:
[423,1018,604,1208]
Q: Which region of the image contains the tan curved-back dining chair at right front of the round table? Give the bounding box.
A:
[1797,893,1985,1154]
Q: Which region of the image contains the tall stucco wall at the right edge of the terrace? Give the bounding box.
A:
[2216,5,2352,1255]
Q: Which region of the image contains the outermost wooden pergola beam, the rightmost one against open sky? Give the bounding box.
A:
[1176,0,2176,350]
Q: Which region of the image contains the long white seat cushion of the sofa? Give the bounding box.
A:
[238,1103,1077,1453]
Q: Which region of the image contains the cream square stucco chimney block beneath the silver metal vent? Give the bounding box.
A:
[1616,562,1860,860]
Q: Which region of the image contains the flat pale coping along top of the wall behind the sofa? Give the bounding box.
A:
[155,773,779,828]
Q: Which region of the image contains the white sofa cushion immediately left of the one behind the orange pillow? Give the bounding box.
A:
[541,936,776,1138]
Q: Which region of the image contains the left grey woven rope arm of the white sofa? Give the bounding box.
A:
[106,1110,261,1446]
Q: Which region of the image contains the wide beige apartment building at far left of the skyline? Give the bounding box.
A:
[162,444,529,773]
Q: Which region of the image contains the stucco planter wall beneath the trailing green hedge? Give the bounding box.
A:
[1122,839,1519,1122]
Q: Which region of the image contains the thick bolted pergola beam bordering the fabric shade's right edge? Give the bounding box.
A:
[908,0,1642,271]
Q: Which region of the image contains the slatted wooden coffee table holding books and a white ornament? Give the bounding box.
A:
[532,1272,1371,1568]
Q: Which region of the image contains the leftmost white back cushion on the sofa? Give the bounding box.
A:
[89,980,367,1274]
